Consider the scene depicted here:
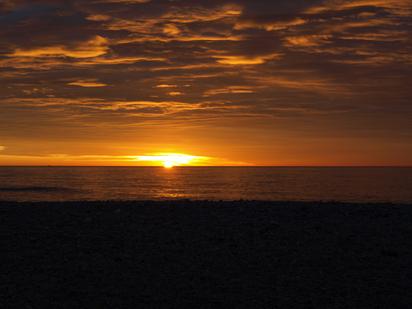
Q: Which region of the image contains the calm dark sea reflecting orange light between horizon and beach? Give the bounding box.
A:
[0,167,412,203]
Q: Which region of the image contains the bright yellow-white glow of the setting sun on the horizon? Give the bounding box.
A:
[136,153,208,169]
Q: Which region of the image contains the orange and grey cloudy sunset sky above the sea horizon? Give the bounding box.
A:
[0,0,412,166]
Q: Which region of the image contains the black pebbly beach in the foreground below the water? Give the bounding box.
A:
[0,201,412,309]
